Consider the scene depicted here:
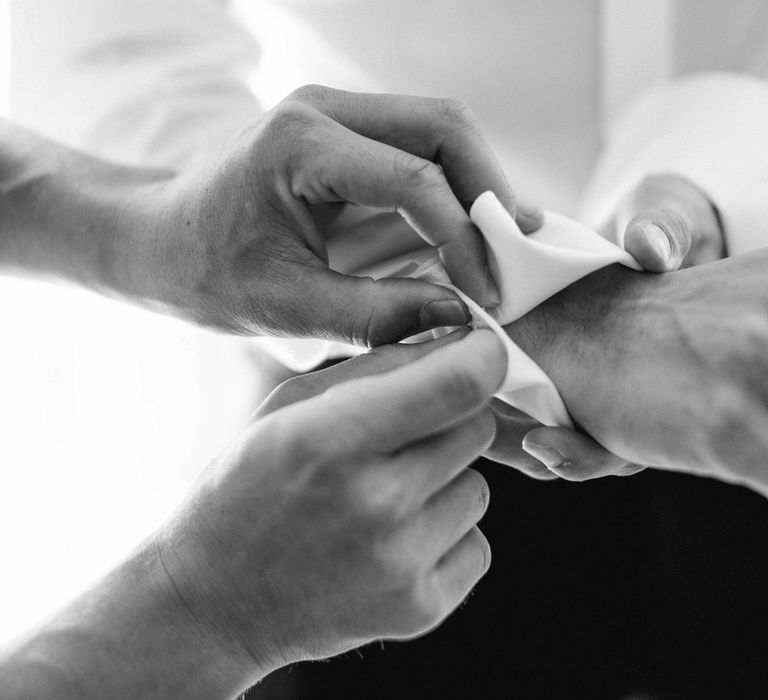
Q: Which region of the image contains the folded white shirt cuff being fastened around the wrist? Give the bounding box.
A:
[411,192,642,427]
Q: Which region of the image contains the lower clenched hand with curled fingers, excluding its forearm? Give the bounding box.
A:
[159,331,505,682]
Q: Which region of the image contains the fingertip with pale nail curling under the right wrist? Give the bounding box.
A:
[523,427,645,481]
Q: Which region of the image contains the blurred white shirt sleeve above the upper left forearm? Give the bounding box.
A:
[10,0,260,167]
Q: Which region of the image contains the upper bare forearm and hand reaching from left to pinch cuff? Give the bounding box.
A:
[0,86,541,345]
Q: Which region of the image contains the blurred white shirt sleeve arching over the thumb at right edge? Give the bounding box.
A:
[581,73,768,254]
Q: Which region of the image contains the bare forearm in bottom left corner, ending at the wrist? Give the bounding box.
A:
[0,532,265,700]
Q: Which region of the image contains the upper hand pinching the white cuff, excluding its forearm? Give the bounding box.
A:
[135,86,541,345]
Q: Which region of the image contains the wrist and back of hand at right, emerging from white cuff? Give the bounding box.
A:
[506,251,768,493]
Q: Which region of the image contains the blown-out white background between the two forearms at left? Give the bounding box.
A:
[0,0,255,643]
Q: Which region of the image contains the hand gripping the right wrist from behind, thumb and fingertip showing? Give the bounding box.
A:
[516,174,725,481]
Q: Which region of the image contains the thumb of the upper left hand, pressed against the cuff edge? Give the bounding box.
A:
[303,269,471,347]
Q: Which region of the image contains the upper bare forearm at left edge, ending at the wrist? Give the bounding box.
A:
[0,121,174,304]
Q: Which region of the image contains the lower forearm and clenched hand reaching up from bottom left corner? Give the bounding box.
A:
[0,331,505,700]
